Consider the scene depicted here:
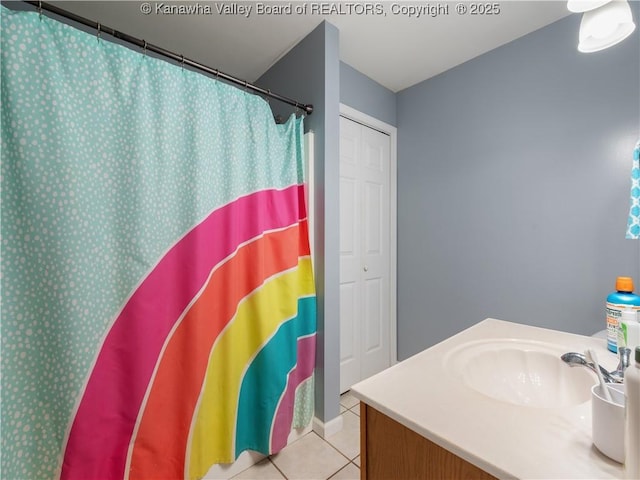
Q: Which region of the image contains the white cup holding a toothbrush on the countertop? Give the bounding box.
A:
[591,383,624,463]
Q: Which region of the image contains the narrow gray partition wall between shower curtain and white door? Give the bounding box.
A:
[256,22,340,422]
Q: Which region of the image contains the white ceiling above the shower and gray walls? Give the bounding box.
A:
[47,0,577,92]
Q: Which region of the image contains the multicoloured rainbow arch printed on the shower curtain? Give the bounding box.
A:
[61,185,316,480]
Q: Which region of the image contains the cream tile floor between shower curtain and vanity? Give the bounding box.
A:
[233,392,360,480]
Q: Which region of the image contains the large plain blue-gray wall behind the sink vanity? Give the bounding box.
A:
[398,12,640,359]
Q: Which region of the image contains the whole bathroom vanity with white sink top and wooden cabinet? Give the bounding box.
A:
[351,319,624,480]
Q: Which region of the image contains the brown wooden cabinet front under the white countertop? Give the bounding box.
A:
[360,402,496,480]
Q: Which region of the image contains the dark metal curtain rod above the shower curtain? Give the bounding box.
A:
[23,0,313,115]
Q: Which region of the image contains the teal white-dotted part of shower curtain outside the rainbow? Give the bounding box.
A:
[0,7,313,479]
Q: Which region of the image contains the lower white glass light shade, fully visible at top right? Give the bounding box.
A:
[578,0,636,53]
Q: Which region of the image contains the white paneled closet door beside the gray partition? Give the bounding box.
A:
[340,117,395,392]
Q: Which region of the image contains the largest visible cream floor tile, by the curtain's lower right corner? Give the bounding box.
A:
[271,432,349,480]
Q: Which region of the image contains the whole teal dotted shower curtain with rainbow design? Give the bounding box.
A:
[0,7,316,480]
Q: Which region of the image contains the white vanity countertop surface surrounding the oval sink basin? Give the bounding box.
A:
[351,318,624,480]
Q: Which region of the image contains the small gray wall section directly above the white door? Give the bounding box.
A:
[340,62,396,127]
